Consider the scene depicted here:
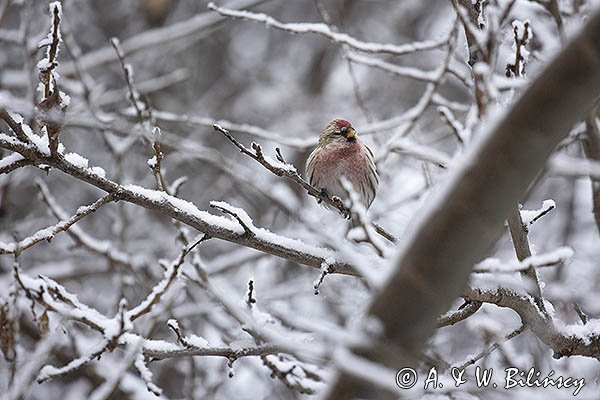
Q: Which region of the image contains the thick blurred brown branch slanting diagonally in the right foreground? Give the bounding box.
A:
[329,7,600,399]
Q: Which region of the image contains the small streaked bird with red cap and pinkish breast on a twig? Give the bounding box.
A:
[306,118,379,208]
